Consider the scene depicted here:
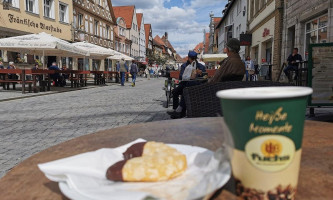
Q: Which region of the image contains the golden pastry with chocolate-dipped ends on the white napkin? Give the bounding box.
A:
[106,142,187,182]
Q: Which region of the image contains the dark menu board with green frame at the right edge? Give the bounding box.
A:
[308,43,333,106]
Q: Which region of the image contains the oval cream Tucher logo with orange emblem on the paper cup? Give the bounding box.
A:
[245,135,295,172]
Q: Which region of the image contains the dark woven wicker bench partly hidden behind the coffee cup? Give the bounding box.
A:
[183,81,292,117]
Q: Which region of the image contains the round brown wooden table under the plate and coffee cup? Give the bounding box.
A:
[0,118,333,200]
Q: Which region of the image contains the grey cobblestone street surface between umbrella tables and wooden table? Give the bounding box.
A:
[0,78,169,178]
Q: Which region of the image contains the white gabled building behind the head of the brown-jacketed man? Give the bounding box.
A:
[216,0,247,59]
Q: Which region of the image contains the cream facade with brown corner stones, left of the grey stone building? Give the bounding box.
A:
[247,0,284,80]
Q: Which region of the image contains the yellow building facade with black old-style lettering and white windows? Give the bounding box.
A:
[0,0,73,64]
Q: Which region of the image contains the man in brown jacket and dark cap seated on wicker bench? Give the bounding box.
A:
[208,38,245,83]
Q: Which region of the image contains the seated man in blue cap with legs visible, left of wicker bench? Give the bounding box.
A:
[168,51,206,119]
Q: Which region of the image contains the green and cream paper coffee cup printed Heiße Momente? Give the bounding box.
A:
[217,87,312,200]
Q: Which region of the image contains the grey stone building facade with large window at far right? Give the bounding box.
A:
[281,0,333,62]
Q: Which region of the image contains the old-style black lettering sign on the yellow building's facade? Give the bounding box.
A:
[8,14,62,33]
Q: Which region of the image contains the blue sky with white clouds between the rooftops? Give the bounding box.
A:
[111,0,227,57]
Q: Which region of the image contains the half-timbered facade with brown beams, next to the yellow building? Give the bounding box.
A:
[73,0,116,70]
